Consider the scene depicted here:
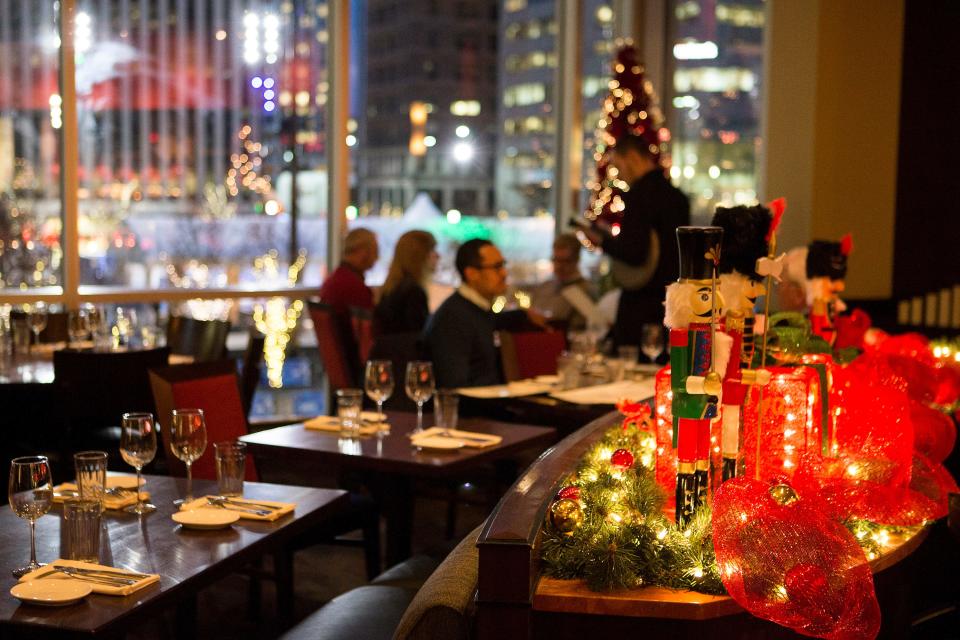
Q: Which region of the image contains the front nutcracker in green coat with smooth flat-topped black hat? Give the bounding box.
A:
[664,227,731,527]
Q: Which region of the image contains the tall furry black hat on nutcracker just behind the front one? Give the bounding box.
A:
[711,204,773,280]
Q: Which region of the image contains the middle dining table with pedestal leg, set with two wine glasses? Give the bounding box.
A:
[240,411,557,566]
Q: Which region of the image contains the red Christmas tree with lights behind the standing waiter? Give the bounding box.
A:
[584,41,670,225]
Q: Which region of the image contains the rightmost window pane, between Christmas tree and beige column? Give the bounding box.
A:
[664,0,764,220]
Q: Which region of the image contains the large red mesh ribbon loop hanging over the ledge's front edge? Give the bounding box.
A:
[713,478,880,639]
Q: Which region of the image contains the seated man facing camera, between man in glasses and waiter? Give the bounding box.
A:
[530,233,596,331]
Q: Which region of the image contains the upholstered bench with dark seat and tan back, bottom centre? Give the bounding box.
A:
[282,527,480,640]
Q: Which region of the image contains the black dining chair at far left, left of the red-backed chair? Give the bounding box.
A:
[53,347,170,469]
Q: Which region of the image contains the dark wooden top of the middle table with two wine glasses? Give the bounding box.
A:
[240,412,556,476]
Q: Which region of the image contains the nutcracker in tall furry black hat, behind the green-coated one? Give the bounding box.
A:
[713,198,786,482]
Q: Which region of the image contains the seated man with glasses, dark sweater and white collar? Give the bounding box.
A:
[423,239,545,388]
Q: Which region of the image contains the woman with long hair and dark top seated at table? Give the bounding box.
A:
[373,231,437,335]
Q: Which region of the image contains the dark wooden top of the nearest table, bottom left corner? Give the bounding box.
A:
[0,476,347,637]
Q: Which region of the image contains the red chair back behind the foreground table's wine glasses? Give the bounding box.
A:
[150,360,258,481]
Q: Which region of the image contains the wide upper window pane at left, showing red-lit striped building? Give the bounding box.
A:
[74,0,327,289]
